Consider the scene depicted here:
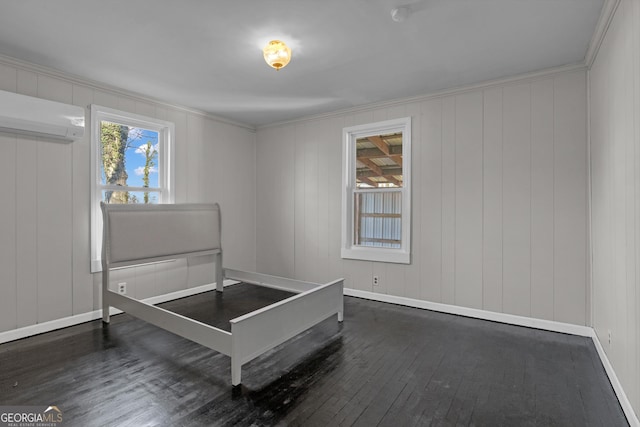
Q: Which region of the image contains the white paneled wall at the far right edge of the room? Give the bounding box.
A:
[589,0,640,415]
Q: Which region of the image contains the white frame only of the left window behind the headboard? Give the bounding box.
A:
[91,105,175,273]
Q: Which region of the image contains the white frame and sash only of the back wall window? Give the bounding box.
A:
[341,117,411,264]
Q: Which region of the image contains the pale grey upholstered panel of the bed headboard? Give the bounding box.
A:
[100,202,222,270]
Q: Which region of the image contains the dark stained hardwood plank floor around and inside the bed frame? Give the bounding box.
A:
[0,284,627,427]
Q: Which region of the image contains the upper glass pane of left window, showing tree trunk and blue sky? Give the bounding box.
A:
[100,121,161,188]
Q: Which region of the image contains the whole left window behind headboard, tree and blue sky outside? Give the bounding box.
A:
[91,105,174,273]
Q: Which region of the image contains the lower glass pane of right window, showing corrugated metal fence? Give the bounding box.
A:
[353,191,402,249]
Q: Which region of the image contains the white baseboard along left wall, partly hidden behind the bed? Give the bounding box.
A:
[0,280,238,344]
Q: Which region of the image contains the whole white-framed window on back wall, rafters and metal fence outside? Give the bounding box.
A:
[342,117,411,264]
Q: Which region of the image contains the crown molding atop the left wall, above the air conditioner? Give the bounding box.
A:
[0,54,256,132]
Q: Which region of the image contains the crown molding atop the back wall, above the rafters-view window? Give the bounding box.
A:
[256,62,587,130]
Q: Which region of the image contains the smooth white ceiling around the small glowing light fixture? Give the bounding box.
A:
[0,0,604,125]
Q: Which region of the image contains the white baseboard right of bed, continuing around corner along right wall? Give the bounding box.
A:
[344,288,640,427]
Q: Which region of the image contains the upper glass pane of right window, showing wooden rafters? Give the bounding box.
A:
[356,132,402,189]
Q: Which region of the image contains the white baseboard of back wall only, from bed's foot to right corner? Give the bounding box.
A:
[344,288,593,337]
